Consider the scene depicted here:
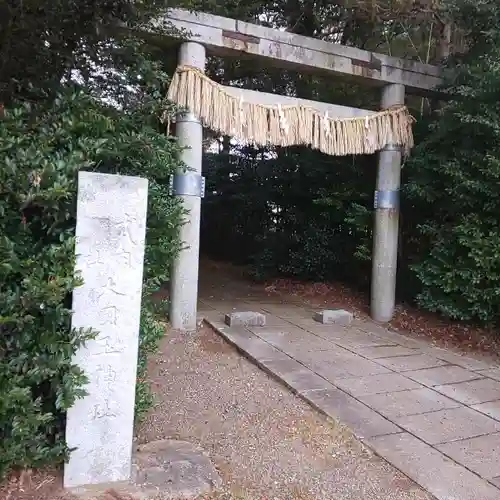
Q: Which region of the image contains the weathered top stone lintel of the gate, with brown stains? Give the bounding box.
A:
[159,9,441,93]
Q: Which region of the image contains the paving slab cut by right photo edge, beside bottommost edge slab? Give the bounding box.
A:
[437,434,500,478]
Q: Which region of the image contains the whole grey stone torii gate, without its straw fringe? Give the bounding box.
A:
[159,9,441,330]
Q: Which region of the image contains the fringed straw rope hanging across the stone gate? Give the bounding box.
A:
[165,66,415,156]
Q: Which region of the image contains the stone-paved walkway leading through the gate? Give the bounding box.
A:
[200,297,500,500]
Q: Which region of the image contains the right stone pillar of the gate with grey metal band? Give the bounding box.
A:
[371,84,405,322]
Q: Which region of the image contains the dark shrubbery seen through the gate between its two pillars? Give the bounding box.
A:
[202,147,376,285]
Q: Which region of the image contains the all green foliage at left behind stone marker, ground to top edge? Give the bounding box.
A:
[0,0,182,476]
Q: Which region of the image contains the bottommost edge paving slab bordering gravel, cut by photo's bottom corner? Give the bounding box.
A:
[365,432,500,500]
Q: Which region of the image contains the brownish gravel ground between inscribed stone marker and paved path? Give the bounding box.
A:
[138,328,433,500]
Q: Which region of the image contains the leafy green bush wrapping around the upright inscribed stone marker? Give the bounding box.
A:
[0,92,182,476]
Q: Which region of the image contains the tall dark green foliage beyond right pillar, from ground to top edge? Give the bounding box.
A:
[405,0,500,323]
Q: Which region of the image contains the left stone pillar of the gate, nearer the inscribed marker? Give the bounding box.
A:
[170,42,206,331]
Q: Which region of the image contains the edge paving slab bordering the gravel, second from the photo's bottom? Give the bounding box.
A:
[301,388,401,439]
